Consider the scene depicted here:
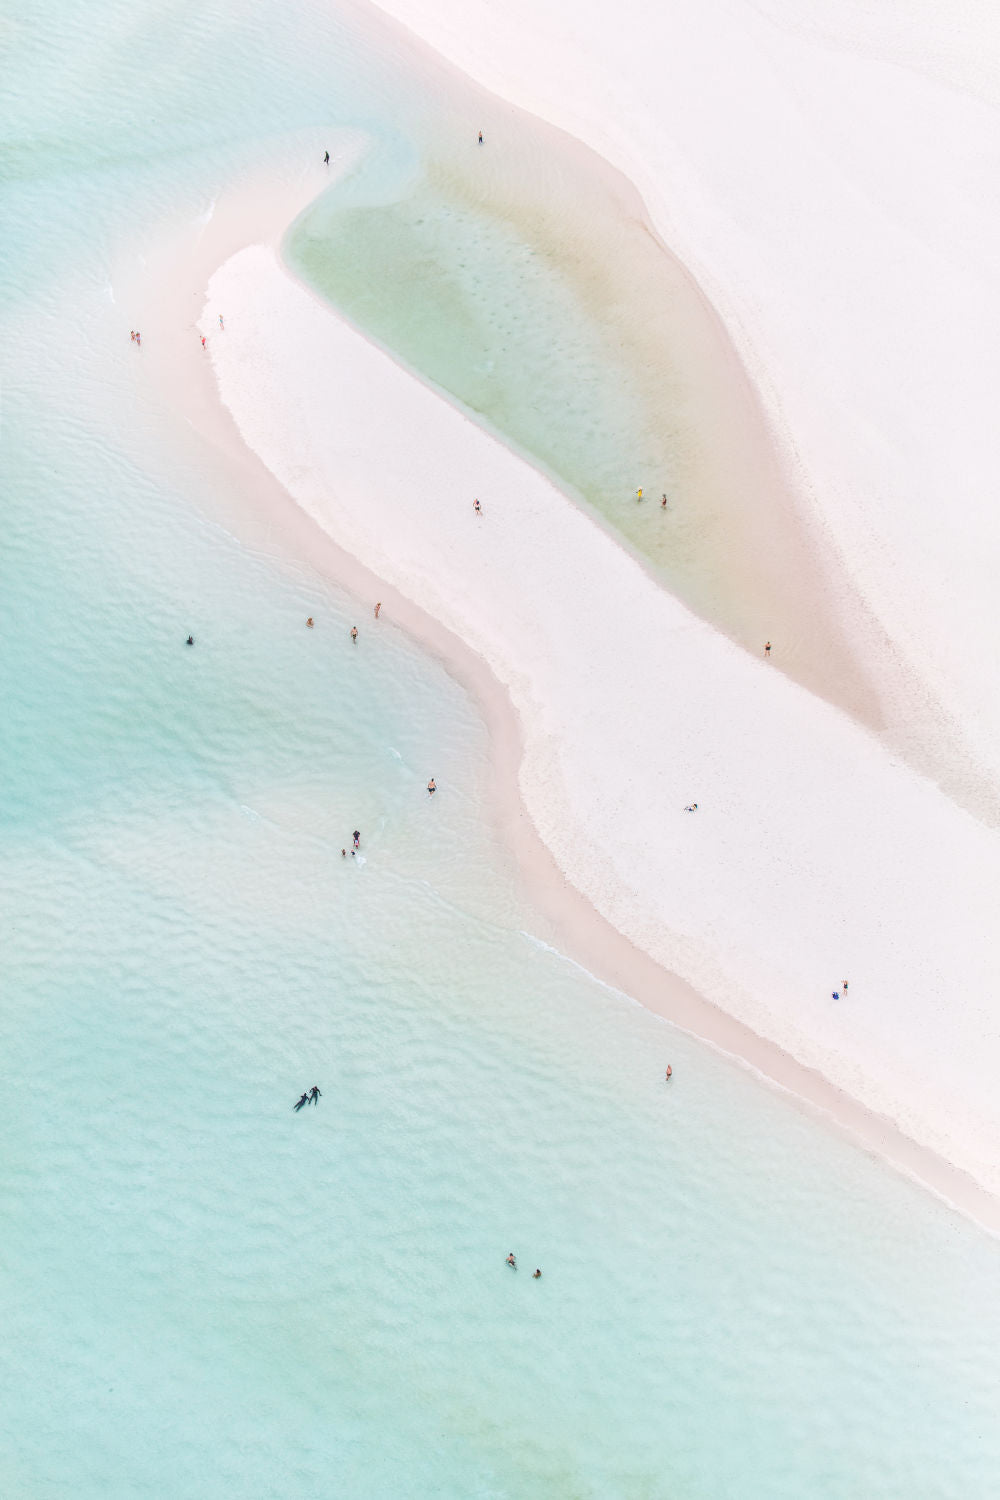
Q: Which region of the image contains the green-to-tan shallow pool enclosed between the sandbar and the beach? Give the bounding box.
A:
[285,57,879,722]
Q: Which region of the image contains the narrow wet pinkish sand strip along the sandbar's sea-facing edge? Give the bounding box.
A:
[121,149,1000,1232]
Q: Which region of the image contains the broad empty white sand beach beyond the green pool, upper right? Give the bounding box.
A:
[370,0,1000,821]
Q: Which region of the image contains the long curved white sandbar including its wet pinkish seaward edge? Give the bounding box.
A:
[122,138,1000,1227]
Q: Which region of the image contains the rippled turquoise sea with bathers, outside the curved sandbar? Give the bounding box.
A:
[0,5,1000,1500]
